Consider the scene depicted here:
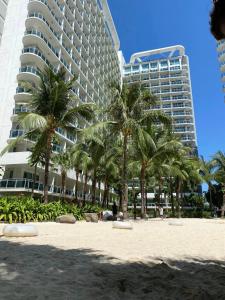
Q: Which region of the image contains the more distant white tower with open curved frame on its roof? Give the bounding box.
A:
[123,46,197,152]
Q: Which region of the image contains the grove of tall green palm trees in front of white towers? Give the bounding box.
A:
[1,69,225,219]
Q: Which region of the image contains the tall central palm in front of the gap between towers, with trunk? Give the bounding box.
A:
[108,84,168,218]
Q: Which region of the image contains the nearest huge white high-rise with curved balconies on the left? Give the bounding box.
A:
[0,0,121,195]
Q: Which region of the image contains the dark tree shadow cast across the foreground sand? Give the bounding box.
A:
[0,238,225,300]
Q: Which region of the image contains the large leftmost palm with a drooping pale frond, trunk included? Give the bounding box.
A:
[20,68,93,203]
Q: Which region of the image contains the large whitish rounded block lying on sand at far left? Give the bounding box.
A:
[3,224,38,237]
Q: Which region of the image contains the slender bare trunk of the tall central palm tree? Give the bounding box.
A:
[122,134,128,219]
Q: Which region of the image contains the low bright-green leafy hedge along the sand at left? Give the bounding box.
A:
[0,197,102,223]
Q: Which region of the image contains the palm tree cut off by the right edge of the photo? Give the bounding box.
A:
[212,151,225,218]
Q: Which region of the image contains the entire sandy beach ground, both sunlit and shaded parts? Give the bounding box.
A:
[0,219,225,300]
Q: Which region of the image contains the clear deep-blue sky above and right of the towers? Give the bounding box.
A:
[108,0,225,159]
